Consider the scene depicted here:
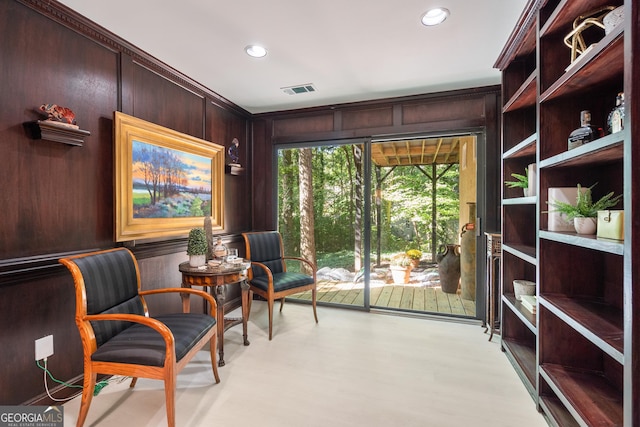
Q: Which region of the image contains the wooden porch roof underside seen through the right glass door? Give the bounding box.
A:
[371,135,474,167]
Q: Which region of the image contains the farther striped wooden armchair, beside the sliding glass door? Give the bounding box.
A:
[242,231,318,339]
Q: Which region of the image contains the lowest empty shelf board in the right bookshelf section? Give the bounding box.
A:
[540,364,623,426]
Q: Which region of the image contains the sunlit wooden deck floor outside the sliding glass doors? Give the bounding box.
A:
[290,268,476,317]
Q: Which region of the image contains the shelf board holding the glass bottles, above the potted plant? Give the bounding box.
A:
[538,132,624,169]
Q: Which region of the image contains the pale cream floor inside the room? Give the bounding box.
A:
[64,301,547,427]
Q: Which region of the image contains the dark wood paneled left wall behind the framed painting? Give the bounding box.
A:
[0,0,251,405]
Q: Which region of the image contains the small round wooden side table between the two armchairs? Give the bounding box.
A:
[178,262,250,366]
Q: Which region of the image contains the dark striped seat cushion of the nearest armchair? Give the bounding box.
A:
[91,313,216,366]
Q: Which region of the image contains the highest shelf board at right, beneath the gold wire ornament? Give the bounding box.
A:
[540,25,624,103]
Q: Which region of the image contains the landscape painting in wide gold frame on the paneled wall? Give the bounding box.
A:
[114,111,225,242]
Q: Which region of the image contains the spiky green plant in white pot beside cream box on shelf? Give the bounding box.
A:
[550,183,622,234]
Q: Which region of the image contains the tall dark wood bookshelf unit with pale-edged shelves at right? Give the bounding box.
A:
[495,0,640,426]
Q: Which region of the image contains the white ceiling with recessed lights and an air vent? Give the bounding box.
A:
[60,0,527,113]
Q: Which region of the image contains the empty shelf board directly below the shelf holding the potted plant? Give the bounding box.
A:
[539,294,624,364]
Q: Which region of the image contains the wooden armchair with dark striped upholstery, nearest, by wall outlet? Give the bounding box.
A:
[60,248,220,427]
